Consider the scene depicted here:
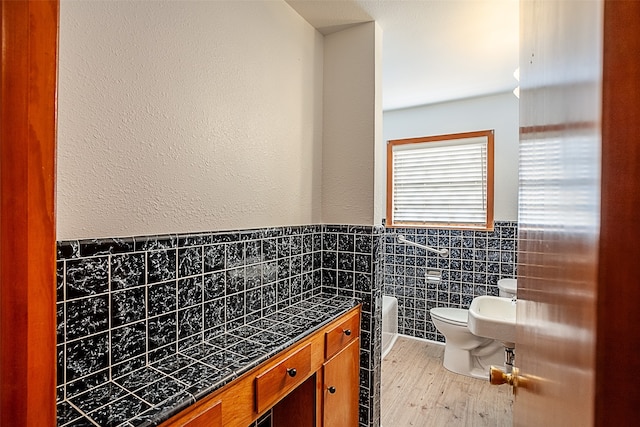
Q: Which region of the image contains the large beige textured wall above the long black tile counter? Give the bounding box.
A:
[57,0,323,240]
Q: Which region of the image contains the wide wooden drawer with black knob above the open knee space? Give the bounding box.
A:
[255,343,311,413]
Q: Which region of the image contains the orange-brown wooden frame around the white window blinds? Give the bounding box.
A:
[386,130,495,231]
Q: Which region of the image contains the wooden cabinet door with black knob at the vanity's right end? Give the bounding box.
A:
[322,338,360,427]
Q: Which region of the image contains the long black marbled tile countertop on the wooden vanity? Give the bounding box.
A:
[57,294,358,427]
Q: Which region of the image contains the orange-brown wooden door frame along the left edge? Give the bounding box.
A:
[0,0,59,427]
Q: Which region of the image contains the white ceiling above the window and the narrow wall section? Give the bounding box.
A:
[286,0,519,110]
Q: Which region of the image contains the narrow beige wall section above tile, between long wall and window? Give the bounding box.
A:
[322,22,382,225]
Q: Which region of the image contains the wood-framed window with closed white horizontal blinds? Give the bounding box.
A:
[387,130,493,230]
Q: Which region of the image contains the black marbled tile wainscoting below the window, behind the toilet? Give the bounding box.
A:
[383,221,518,342]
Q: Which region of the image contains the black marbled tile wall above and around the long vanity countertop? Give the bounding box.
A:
[57,225,384,427]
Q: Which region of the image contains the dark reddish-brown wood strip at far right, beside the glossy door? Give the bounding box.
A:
[594,0,640,426]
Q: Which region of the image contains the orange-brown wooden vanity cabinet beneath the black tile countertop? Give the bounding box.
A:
[161,305,361,427]
